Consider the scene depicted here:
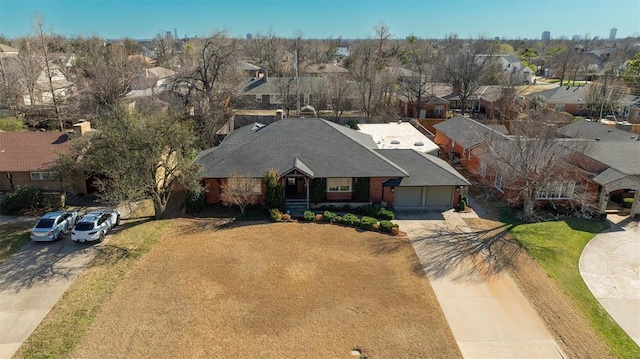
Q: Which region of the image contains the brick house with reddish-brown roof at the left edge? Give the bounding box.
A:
[0,132,87,193]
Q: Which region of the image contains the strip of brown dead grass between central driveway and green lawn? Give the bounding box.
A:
[465,218,614,358]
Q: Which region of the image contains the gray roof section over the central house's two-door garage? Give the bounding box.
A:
[376,149,469,187]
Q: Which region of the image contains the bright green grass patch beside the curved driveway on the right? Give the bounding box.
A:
[501,212,640,358]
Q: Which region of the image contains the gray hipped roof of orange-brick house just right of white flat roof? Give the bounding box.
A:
[433,115,503,149]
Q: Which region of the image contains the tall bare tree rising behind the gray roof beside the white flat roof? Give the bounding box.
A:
[440,34,500,112]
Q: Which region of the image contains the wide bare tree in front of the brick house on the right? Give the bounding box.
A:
[485,110,594,220]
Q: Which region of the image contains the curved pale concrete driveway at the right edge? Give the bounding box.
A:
[580,220,640,345]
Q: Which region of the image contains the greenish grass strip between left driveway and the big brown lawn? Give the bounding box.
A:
[15,220,171,358]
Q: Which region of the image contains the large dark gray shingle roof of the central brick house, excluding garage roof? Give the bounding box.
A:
[196,118,408,178]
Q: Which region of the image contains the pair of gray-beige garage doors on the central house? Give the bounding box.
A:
[394,186,454,209]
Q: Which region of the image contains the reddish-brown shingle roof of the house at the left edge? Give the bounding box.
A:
[0,132,69,172]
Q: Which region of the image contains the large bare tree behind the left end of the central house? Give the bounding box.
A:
[173,31,244,145]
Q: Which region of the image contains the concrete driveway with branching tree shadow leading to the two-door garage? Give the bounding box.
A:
[396,210,564,358]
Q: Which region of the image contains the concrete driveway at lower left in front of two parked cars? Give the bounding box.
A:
[0,235,97,359]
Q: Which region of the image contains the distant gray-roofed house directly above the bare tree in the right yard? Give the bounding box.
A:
[527,84,591,116]
